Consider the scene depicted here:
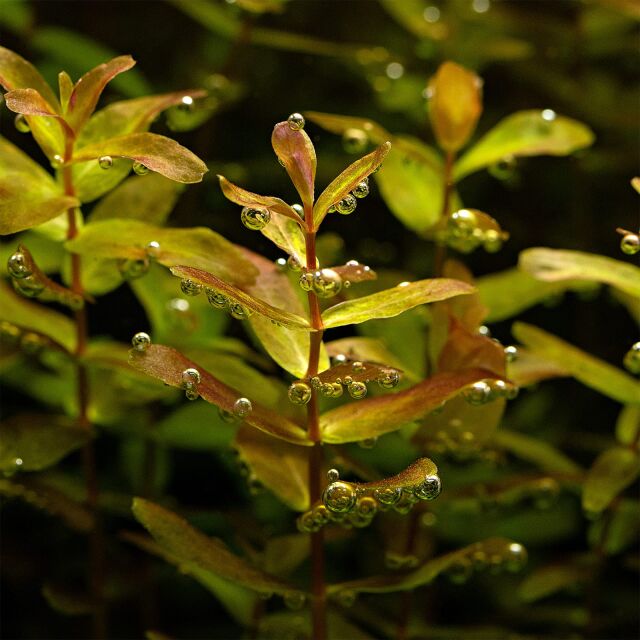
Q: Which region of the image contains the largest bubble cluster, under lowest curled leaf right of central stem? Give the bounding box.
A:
[297,469,442,533]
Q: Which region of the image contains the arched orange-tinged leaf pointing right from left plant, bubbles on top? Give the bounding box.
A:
[73,133,208,183]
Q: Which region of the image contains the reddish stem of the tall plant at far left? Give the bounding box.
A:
[62,154,107,639]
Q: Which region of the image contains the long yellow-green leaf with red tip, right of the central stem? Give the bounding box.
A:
[320,369,496,444]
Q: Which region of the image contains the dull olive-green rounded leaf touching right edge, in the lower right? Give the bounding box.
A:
[582,447,640,513]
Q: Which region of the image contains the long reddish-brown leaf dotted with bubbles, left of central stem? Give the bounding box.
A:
[130,345,312,446]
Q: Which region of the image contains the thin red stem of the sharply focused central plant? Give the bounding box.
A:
[305,218,327,640]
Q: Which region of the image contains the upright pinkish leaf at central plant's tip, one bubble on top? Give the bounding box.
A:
[271,122,316,211]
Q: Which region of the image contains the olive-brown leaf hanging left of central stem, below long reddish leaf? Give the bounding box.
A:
[234,426,309,511]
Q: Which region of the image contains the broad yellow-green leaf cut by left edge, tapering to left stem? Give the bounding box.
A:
[0,137,79,235]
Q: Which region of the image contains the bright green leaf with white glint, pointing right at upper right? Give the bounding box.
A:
[453,110,594,181]
